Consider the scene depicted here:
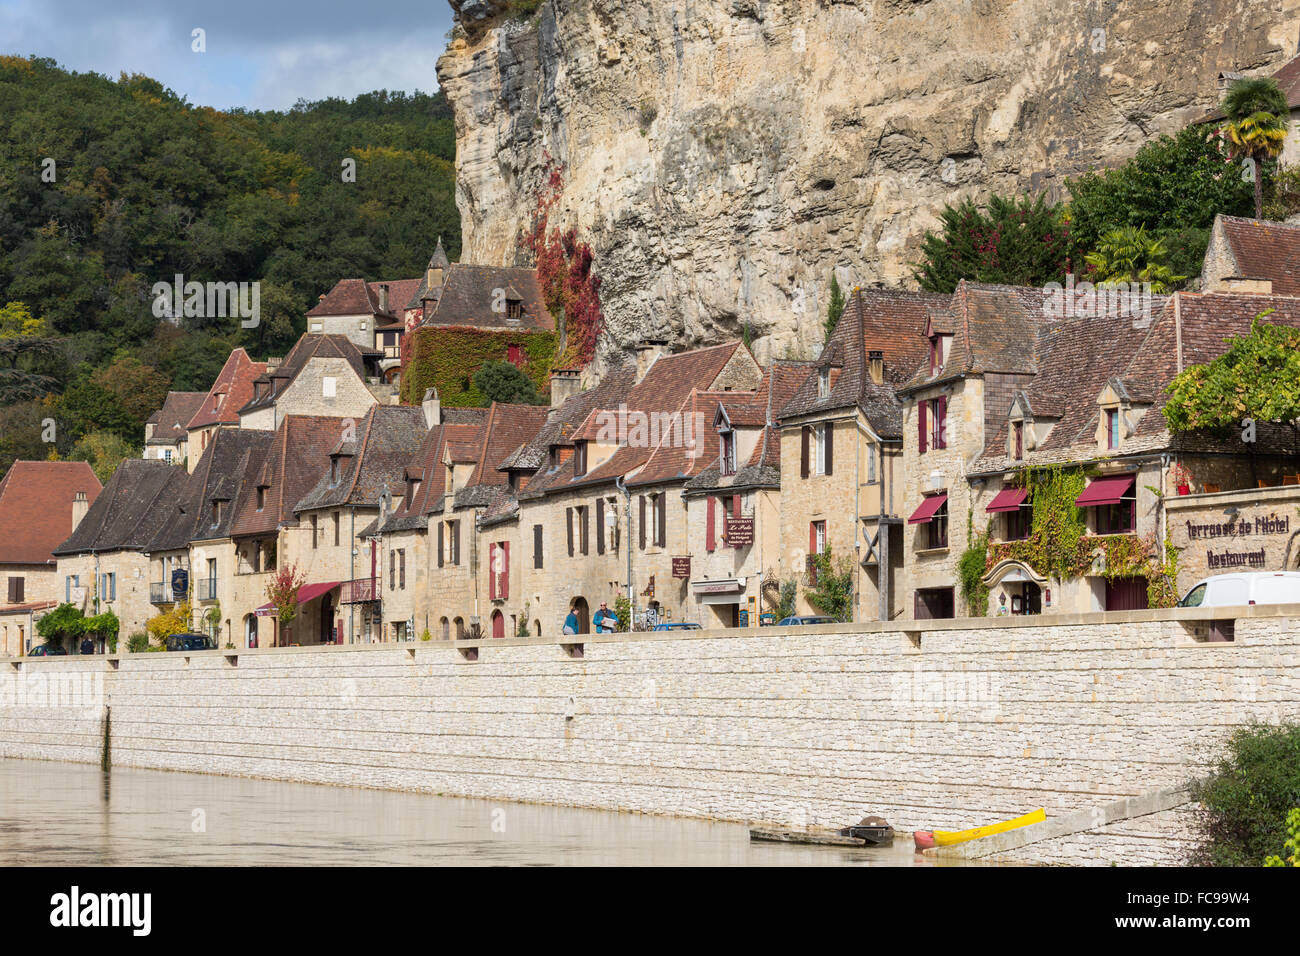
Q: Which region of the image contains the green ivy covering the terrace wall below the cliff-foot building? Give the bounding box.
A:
[402,328,558,408]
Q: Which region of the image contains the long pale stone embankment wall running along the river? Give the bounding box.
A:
[0,606,1300,864]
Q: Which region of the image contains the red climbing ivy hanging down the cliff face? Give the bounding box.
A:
[521,153,605,367]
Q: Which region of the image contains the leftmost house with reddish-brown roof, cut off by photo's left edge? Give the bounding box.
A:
[0,462,101,657]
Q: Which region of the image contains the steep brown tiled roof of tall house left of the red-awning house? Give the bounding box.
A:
[779,289,952,437]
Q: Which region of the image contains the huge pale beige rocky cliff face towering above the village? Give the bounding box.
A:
[438,0,1300,358]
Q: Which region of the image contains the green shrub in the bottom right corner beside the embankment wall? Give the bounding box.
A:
[1188,723,1300,866]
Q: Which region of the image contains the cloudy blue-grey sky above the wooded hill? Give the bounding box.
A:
[0,0,451,109]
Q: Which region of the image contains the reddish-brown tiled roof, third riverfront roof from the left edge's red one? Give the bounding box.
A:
[230,415,345,537]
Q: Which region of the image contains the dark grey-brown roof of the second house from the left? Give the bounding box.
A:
[53,458,190,554]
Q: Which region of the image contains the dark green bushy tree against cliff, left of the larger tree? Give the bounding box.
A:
[913,195,1071,293]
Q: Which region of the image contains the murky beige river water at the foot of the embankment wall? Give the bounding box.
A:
[0,760,956,866]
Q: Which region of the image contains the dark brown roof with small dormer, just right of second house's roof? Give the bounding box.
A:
[144,428,276,551]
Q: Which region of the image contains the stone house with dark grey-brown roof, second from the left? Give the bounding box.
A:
[53,458,189,644]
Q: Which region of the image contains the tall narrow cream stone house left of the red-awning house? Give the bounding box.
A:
[774,289,950,620]
